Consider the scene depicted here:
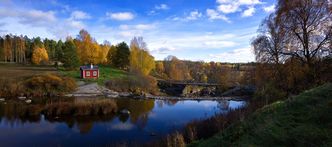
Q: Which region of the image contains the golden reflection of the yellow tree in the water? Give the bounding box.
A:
[117,99,154,128]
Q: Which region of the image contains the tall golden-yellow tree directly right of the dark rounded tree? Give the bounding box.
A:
[129,37,155,75]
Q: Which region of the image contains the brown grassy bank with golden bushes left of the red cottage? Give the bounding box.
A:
[0,63,76,98]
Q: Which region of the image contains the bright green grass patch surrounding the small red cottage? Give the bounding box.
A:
[60,65,130,85]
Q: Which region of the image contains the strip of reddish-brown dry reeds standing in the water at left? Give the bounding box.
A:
[0,98,117,120]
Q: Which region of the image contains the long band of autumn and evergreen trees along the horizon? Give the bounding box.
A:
[0,30,254,86]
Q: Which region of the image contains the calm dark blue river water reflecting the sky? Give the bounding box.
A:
[0,99,245,146]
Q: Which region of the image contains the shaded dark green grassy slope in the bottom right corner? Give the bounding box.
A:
[190,84,332,147]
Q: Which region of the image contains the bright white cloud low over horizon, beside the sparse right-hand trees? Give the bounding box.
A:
[209,47,255,63]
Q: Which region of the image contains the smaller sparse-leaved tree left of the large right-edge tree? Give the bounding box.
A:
[251,13,287,87]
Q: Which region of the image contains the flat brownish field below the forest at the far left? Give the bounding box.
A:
[0,63,58,79]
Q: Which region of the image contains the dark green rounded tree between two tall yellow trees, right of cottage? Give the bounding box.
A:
[112,42,130,69]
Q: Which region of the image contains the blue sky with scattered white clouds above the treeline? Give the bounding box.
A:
[0,0,276,62]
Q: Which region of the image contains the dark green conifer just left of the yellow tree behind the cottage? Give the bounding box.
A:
[63,40,79,69]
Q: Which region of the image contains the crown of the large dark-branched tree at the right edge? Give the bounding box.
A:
[277,0,332,66]
